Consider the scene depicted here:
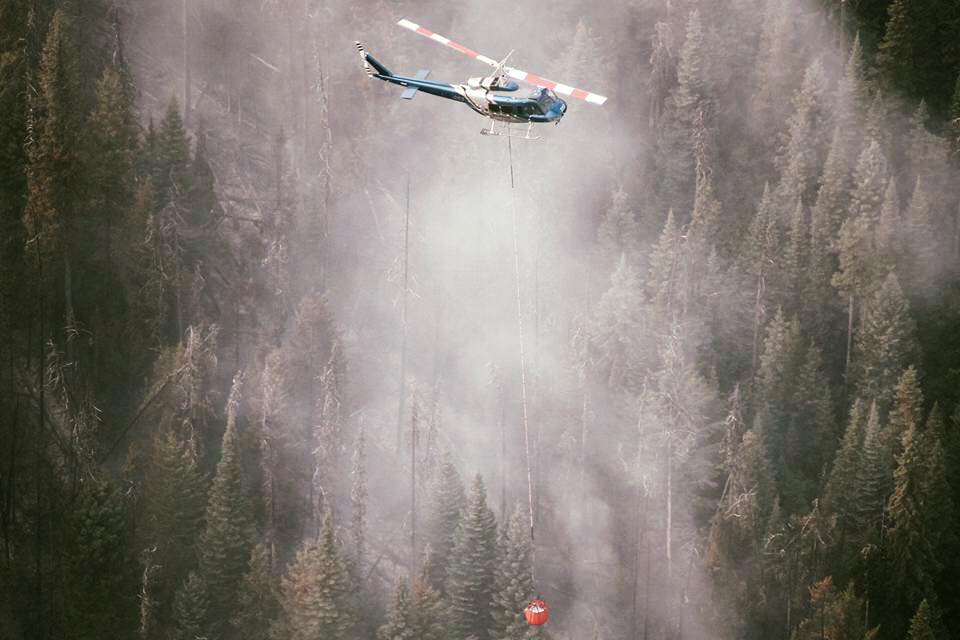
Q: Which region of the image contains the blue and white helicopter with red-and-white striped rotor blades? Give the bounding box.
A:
[356,18,607,140]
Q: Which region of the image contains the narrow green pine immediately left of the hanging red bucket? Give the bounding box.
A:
[491,505,538,640]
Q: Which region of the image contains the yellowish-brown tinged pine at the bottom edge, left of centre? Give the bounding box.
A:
[273,511,355,640]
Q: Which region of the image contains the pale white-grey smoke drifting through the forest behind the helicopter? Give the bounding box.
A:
[126,0,960,638]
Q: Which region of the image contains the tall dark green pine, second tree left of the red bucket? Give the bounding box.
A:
[447,474,497,640]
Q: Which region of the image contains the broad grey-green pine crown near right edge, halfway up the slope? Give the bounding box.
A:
[853,273,920,413]
